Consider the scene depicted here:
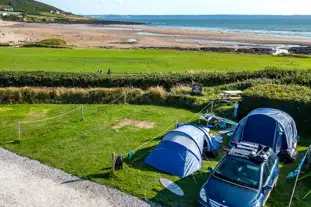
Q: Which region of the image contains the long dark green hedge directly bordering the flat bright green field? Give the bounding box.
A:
[0,69,302,89]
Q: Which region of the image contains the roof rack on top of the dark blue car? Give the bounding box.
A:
[229,142,270,163]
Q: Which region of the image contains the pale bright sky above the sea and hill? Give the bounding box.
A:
[38,0,311,15]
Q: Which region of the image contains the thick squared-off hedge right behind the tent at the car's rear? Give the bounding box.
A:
[239,84,311,133]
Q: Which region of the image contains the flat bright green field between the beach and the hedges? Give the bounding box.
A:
[0,48,311,72]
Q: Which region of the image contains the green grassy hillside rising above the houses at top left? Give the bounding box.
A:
[0,0,63,14]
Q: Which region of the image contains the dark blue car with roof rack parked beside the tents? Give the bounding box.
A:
[198,142,279,207]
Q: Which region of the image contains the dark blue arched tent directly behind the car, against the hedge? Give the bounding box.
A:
[232,108,298,154]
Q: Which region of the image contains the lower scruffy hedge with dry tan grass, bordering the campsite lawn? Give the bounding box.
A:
[0,87,212,110]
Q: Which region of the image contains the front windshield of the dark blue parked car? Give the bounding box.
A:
[214,156,260,189]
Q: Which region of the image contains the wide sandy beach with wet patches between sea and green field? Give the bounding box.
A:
[0,21,311,48]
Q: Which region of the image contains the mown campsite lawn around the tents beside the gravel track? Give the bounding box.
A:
[0,105,311,207]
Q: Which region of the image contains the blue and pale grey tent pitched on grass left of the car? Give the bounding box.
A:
[145,124,214,178]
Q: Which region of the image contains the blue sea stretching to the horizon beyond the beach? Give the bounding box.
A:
[91,15,311,38]
